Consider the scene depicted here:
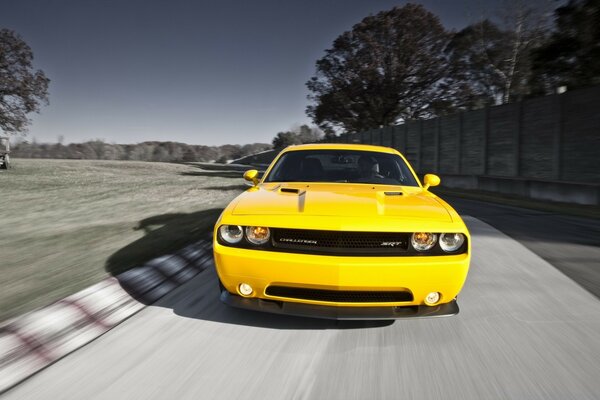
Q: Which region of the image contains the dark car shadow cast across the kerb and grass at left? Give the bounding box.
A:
[105,208,393,329]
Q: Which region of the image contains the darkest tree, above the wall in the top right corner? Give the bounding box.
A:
[532,0,600,94]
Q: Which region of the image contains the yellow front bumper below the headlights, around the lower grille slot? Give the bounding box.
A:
[213,242,470,309]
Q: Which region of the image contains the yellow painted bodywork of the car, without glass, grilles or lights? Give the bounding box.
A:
[213,144,471,307]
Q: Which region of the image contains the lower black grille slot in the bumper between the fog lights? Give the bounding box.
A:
[266,286,413,303]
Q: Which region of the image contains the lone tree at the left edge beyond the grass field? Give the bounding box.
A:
[0,29,50,133]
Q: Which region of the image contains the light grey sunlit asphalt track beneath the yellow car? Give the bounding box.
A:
[5,218,600,400]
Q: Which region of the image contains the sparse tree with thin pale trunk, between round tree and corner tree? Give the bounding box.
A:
[447,0,546,109]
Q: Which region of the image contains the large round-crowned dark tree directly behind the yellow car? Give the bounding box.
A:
[306,4,452,132]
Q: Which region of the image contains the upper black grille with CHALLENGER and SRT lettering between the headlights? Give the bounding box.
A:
[272,228,409,255]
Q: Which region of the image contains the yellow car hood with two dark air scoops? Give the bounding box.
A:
[232,183,452,222]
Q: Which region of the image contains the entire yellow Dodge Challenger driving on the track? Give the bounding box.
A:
[213,144,471,319]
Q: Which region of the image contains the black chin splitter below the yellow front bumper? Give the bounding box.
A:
[221,290,459,320]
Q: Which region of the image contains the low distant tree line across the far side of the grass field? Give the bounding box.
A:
[11,140,271,163]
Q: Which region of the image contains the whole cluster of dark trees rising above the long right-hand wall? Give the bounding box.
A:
[306,0,600,135]
